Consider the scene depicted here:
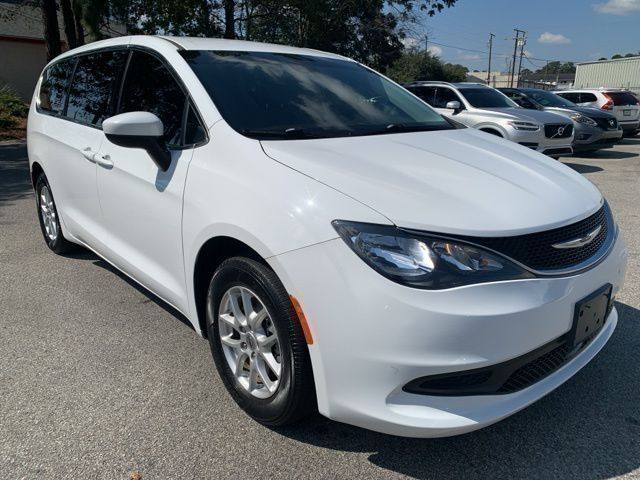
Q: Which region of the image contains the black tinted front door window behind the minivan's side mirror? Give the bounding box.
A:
[120,51,186,146]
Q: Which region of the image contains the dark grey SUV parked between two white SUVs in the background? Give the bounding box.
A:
[498,88,623,153]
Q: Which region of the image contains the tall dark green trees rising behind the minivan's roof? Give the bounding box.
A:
[79,0,457,72]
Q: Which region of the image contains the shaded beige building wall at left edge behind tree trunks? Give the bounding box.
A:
[0,37,47,102]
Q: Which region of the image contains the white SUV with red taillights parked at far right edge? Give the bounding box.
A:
[553,88,640,136]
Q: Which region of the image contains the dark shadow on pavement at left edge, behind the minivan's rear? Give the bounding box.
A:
[0,143,33,206]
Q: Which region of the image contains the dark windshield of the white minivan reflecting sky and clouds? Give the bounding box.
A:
[181,50,454,140]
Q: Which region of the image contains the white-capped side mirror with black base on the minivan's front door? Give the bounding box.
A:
[102,112,171,171]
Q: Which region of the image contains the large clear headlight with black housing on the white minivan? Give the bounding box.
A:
[333,220,534,290]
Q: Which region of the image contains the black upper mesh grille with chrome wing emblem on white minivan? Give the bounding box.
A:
[462,204,612,271]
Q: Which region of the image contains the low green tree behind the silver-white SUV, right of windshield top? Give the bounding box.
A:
[386,49,469,83]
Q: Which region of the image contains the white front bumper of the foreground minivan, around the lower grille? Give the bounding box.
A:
[269,233,627,437]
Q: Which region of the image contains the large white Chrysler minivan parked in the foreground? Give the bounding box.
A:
[28,36,627,437]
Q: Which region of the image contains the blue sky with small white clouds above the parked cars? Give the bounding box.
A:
[405,0,640,71]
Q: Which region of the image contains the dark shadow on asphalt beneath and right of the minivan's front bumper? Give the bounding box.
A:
[275,303,640,480]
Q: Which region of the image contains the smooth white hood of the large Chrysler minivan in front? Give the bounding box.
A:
[261,128,602,236]
